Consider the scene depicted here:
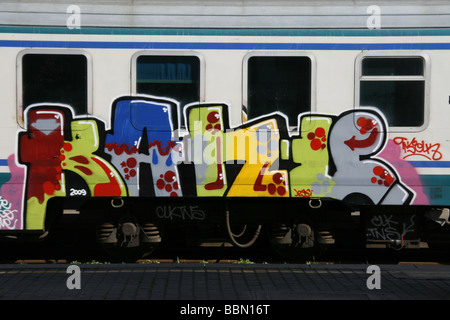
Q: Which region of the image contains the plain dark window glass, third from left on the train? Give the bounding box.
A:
[244,53,313,127]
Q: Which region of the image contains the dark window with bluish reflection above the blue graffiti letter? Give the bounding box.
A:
[133,54,203,125]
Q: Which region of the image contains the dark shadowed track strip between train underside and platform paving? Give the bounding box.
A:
[0,236,450,264]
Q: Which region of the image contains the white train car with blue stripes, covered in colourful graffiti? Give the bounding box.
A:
[0,0,450,256]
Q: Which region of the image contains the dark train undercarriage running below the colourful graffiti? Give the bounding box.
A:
[4,197,450,259]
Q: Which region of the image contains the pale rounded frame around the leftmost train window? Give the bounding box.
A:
[16,49,93,128]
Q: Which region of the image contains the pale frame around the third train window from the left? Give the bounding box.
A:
[242,51,317,131]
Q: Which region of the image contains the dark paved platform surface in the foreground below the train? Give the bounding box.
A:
[0,263,450,303]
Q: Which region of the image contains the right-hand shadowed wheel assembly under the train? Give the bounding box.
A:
[269,223,334,262]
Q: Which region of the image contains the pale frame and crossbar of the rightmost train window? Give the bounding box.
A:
[354,51,430,132]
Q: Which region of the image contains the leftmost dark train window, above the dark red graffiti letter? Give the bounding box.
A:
[18,51,90,122]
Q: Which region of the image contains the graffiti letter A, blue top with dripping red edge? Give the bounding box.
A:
[104,97,182,197]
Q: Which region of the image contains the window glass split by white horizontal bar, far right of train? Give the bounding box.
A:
[357,55,428,131]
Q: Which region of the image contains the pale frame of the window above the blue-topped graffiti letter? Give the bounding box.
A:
[130,50,205,128]
